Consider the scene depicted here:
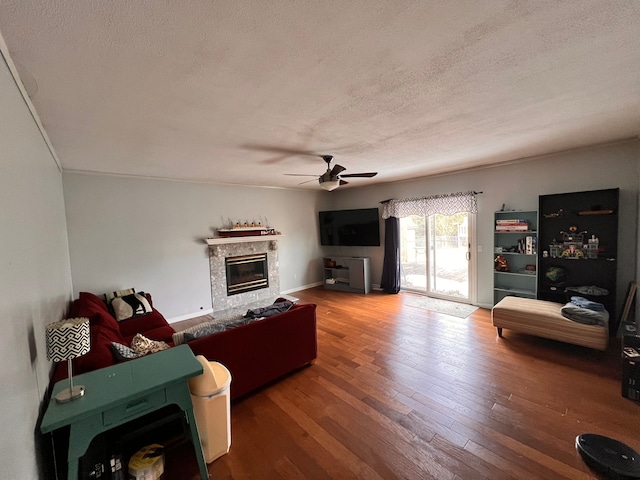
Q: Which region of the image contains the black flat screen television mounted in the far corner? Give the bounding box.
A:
[319,208,380,247]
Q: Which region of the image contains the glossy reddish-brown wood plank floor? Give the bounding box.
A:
[176,287,640,479]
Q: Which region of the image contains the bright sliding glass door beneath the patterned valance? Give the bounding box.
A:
[400,212,475,303]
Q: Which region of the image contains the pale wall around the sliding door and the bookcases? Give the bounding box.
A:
[334,141,639,311]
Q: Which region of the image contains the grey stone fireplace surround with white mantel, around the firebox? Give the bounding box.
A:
[207,236,280,316]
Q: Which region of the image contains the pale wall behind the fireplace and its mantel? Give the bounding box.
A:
[63,173,328,320]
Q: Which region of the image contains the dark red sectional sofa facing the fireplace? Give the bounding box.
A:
[52,292,318,400]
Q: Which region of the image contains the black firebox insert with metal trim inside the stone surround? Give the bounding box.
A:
[225,253,269,296]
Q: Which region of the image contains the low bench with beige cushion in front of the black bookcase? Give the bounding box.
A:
[491,296,609,350]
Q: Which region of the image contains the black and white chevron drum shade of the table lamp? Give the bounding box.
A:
[46,317,91,362]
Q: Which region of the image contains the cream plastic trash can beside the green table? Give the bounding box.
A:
[189,355,231,463]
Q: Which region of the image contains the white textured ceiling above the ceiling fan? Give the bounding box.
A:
[0,0,640,189]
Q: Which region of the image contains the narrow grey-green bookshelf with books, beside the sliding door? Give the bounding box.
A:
[493,210,538,305]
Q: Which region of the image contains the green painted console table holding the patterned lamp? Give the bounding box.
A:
[40,345,209,480]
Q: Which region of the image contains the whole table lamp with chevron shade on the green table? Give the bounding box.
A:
[46,317,91,403]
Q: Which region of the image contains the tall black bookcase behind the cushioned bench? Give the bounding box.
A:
[538,188,619,334]
